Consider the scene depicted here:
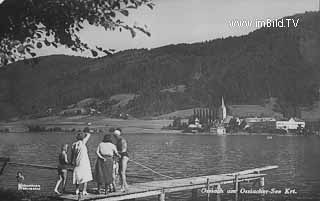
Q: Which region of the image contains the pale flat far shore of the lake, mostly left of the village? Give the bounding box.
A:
[0,115,318,136]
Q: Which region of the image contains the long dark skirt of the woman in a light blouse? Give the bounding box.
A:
[94,156,113,185]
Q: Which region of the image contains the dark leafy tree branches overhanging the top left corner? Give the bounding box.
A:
[0,0,154,66]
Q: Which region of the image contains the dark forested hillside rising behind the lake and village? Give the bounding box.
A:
[0,12,320,119]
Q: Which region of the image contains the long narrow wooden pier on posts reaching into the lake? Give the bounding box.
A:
[59,166,278,201]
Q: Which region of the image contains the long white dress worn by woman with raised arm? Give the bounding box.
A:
[72,140,92,184]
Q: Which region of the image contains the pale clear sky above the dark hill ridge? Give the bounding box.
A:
[37,0,319,56]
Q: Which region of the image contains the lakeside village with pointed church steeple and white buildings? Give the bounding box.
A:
[167,97,319,135]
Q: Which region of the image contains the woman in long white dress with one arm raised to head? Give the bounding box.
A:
[71,133,92,195]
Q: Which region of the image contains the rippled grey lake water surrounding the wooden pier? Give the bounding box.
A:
[0,133,320,200]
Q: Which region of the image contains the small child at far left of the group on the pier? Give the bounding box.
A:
[54,144,68,195]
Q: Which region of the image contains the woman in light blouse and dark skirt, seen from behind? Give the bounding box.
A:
[95,135,119,194]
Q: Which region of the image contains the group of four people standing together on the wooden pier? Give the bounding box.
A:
[54,128,129,195]
